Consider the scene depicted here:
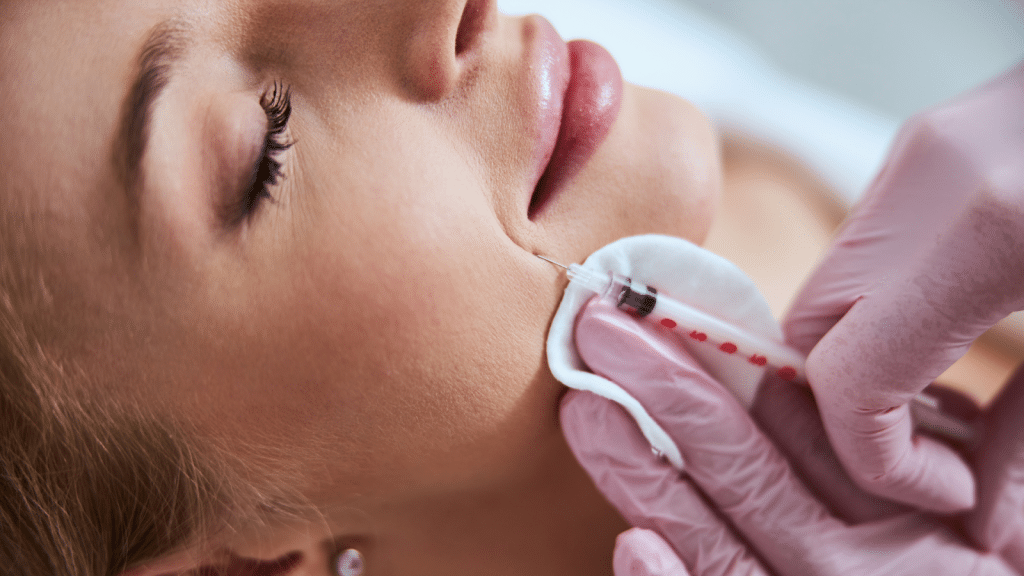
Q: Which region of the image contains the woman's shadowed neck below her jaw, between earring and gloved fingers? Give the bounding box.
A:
[382,424,628,576]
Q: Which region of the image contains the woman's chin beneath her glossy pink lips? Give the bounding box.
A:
[539,84,722,261]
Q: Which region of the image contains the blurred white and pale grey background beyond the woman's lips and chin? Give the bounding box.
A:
[498,0,1024,205]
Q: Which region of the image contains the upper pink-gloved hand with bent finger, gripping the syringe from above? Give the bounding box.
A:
[784,65,1024,512]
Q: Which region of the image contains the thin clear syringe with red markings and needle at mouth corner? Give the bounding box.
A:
[537,254,976,444]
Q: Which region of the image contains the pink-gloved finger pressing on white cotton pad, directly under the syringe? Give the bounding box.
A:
[575,300,843,573]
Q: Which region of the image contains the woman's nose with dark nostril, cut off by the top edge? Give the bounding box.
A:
[402,0,498,101]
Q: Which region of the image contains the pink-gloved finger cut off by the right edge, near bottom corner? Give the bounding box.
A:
[967,366,1024,573]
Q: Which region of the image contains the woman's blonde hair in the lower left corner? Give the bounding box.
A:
[0,268,308,576]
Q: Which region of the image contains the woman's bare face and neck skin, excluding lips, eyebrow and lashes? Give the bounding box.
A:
[0,0,720,575]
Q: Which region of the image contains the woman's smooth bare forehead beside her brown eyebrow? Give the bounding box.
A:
[0,0,181,323]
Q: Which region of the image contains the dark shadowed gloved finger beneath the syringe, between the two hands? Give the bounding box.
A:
[751,374,910,524]
